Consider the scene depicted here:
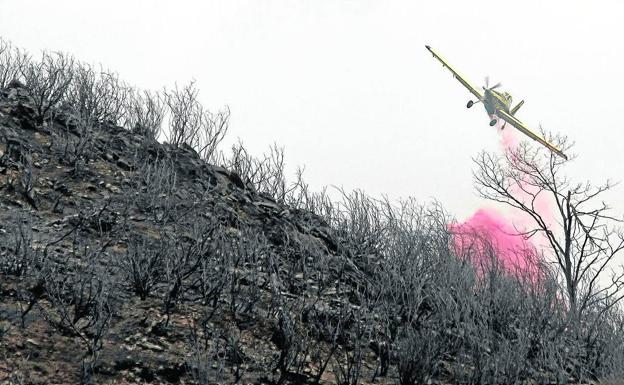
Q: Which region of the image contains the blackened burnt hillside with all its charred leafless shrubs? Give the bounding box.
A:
[0,36,624,385]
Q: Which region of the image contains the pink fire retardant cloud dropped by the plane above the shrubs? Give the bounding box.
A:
[449,118,552,281]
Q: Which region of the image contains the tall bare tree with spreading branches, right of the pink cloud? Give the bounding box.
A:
[474,137,624,319]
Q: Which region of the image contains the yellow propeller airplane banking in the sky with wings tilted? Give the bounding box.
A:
[425,45,568,160]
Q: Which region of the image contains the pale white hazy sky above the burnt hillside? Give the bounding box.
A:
[0,0,624,219]
